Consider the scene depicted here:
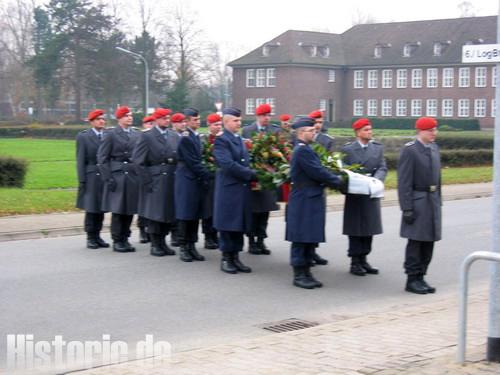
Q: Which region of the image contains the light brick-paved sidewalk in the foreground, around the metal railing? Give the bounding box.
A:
[78,285,500,375]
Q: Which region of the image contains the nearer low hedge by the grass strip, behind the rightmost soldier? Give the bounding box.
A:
[385,150,493,169]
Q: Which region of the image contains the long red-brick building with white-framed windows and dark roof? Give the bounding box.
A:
[228,16,497,128]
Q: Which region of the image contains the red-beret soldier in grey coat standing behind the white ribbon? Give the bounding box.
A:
[342,118,387,276]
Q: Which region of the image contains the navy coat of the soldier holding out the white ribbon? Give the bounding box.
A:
[286,141,341,243]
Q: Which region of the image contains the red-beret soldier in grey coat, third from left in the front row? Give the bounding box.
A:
[132,108,178,257]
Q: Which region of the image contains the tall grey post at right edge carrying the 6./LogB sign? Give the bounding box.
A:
[486,0,500,362]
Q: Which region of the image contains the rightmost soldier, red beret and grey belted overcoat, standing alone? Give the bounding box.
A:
[398,117,442,294]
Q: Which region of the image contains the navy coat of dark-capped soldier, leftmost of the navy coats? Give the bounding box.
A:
[175,129,210,220]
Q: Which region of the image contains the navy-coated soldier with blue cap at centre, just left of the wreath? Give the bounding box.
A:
[214,108,257,273]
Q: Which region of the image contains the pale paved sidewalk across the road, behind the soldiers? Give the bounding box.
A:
[0,182,493,241]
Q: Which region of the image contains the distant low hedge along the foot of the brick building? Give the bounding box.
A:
[340,117,481,130]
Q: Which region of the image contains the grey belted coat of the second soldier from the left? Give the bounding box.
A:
[97,126,141,215]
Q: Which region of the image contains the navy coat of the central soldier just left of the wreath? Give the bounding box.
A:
[214,131,255,232]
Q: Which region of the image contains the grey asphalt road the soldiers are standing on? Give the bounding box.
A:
[0,198,491,372]
